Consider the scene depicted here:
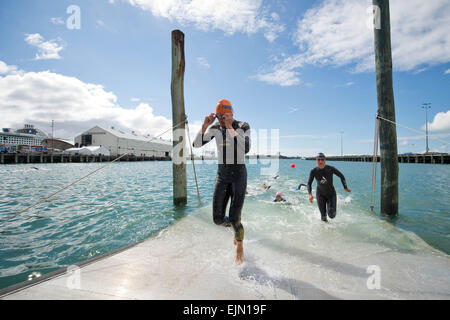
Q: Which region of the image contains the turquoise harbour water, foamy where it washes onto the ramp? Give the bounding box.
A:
[0,160,450,288]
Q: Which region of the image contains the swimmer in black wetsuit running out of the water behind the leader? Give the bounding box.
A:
[308,153,352,222]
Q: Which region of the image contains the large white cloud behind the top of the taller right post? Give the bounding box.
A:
[256,0,450,85]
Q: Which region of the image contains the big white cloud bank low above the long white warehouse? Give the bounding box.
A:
[0,61,172,139]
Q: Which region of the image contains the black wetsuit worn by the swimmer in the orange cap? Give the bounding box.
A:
[194,120,250,241]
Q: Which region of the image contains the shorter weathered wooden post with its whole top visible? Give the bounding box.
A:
[170,30,187,205]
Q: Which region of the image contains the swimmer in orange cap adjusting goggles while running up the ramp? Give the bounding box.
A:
[193,100,250,264]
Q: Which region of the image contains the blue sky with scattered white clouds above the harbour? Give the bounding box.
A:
[0,0,450,156]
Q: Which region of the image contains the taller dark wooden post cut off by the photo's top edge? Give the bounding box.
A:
[372,0,398,215]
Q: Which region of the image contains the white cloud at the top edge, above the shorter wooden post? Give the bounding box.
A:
[122,0,284,41]
